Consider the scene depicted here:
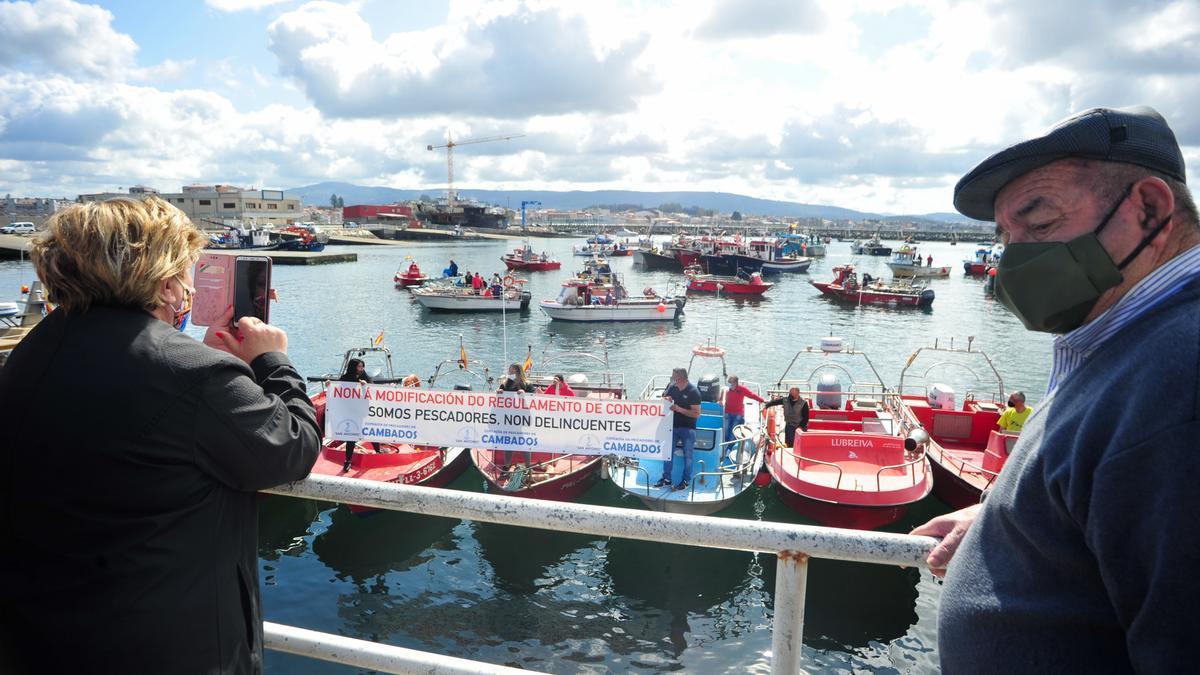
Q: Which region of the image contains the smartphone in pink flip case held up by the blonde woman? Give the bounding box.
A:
[192,253,271,325]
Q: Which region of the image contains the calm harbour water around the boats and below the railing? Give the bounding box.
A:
[0,239,1050,673]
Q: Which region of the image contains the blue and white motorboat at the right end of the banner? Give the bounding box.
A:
[608,341,766,515]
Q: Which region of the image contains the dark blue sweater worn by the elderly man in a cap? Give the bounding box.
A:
[937,276,1200,673]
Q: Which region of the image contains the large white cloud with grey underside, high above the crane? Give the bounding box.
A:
[268,1,656,118]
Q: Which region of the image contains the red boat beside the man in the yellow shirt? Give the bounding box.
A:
[893,338,1018,508]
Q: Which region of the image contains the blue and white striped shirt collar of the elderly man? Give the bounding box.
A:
[1046,245,1200,394]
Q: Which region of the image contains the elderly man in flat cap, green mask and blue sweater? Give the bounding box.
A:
[914,108,1200,673]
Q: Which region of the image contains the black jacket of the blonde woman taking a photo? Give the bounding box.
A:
[0,307,320,673]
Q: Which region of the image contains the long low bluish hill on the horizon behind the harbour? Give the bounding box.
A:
[288,183,984,222]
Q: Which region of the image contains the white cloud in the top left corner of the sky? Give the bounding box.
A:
[0,0,138,77]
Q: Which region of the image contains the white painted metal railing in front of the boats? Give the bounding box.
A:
[264,476,937,674]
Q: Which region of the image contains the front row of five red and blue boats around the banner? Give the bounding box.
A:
[310,338,1018,528]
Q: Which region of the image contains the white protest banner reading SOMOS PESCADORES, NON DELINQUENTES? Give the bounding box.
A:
[325,382,672,460]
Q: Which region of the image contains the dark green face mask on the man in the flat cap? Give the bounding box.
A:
[996,184,1171,333]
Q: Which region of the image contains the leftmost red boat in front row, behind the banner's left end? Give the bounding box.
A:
[308,346,469,513]
